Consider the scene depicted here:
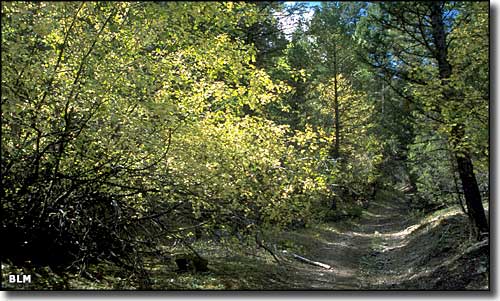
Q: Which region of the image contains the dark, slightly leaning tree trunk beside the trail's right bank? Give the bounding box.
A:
[429,2,489,234]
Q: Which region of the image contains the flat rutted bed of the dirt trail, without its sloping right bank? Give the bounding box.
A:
[289,195,413,290]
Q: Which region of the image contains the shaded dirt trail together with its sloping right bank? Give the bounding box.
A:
[274,189,489,290]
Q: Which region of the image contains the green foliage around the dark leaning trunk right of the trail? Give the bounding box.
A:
[357,2,489,214]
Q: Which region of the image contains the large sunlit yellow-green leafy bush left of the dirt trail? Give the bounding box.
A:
[2,2,328,269]
